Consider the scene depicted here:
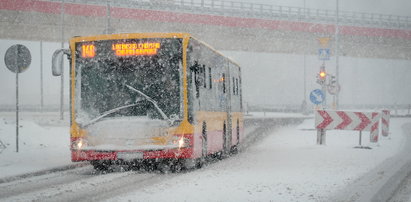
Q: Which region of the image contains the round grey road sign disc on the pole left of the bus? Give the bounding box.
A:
[4,44,31,73]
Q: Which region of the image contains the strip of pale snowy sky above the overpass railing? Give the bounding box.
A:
[238,0,411,16]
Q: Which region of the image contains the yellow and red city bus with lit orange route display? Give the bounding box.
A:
[52,33,244,169]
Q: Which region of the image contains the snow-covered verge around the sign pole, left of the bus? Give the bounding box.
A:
[0,112,71,178]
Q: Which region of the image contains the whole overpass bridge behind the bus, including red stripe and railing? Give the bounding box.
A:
[0,0,411,60]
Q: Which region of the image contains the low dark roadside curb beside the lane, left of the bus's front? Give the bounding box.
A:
[0,162,90,184]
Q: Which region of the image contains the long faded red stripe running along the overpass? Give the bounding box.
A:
[0,0,411,39]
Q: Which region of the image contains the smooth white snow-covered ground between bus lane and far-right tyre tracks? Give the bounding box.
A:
[109,119,411,201]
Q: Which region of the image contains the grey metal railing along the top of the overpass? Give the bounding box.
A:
[48,0,411,30]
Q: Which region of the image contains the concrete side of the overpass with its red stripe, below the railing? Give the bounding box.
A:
[0,0,411,60]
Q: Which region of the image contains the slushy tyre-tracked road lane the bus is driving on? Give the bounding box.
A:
[0,118,303,201]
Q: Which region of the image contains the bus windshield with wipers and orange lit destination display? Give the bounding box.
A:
[75,38,182,124]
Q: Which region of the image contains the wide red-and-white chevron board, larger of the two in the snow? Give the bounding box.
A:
[315,110,381,142]
